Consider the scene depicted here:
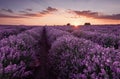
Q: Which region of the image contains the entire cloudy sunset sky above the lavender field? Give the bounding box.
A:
[0,0,120,25]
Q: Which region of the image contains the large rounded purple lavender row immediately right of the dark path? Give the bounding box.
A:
[49,35,120,79]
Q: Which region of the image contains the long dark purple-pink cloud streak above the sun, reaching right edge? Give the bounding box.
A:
[68,10,120,20]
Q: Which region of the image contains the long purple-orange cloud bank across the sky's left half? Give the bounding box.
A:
[0,7,58,18]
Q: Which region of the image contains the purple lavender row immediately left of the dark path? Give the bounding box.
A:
[0,27,43,79]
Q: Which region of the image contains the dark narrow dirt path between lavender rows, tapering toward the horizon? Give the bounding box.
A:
[34,28,56,79]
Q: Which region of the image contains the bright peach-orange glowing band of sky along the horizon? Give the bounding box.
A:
[0,13,120,27]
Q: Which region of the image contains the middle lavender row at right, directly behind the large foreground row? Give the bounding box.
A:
[72,30,120,49]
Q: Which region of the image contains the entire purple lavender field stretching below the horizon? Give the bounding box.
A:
[0,25,120,79]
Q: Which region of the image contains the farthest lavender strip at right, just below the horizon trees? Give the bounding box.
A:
[75,25,120,36]
